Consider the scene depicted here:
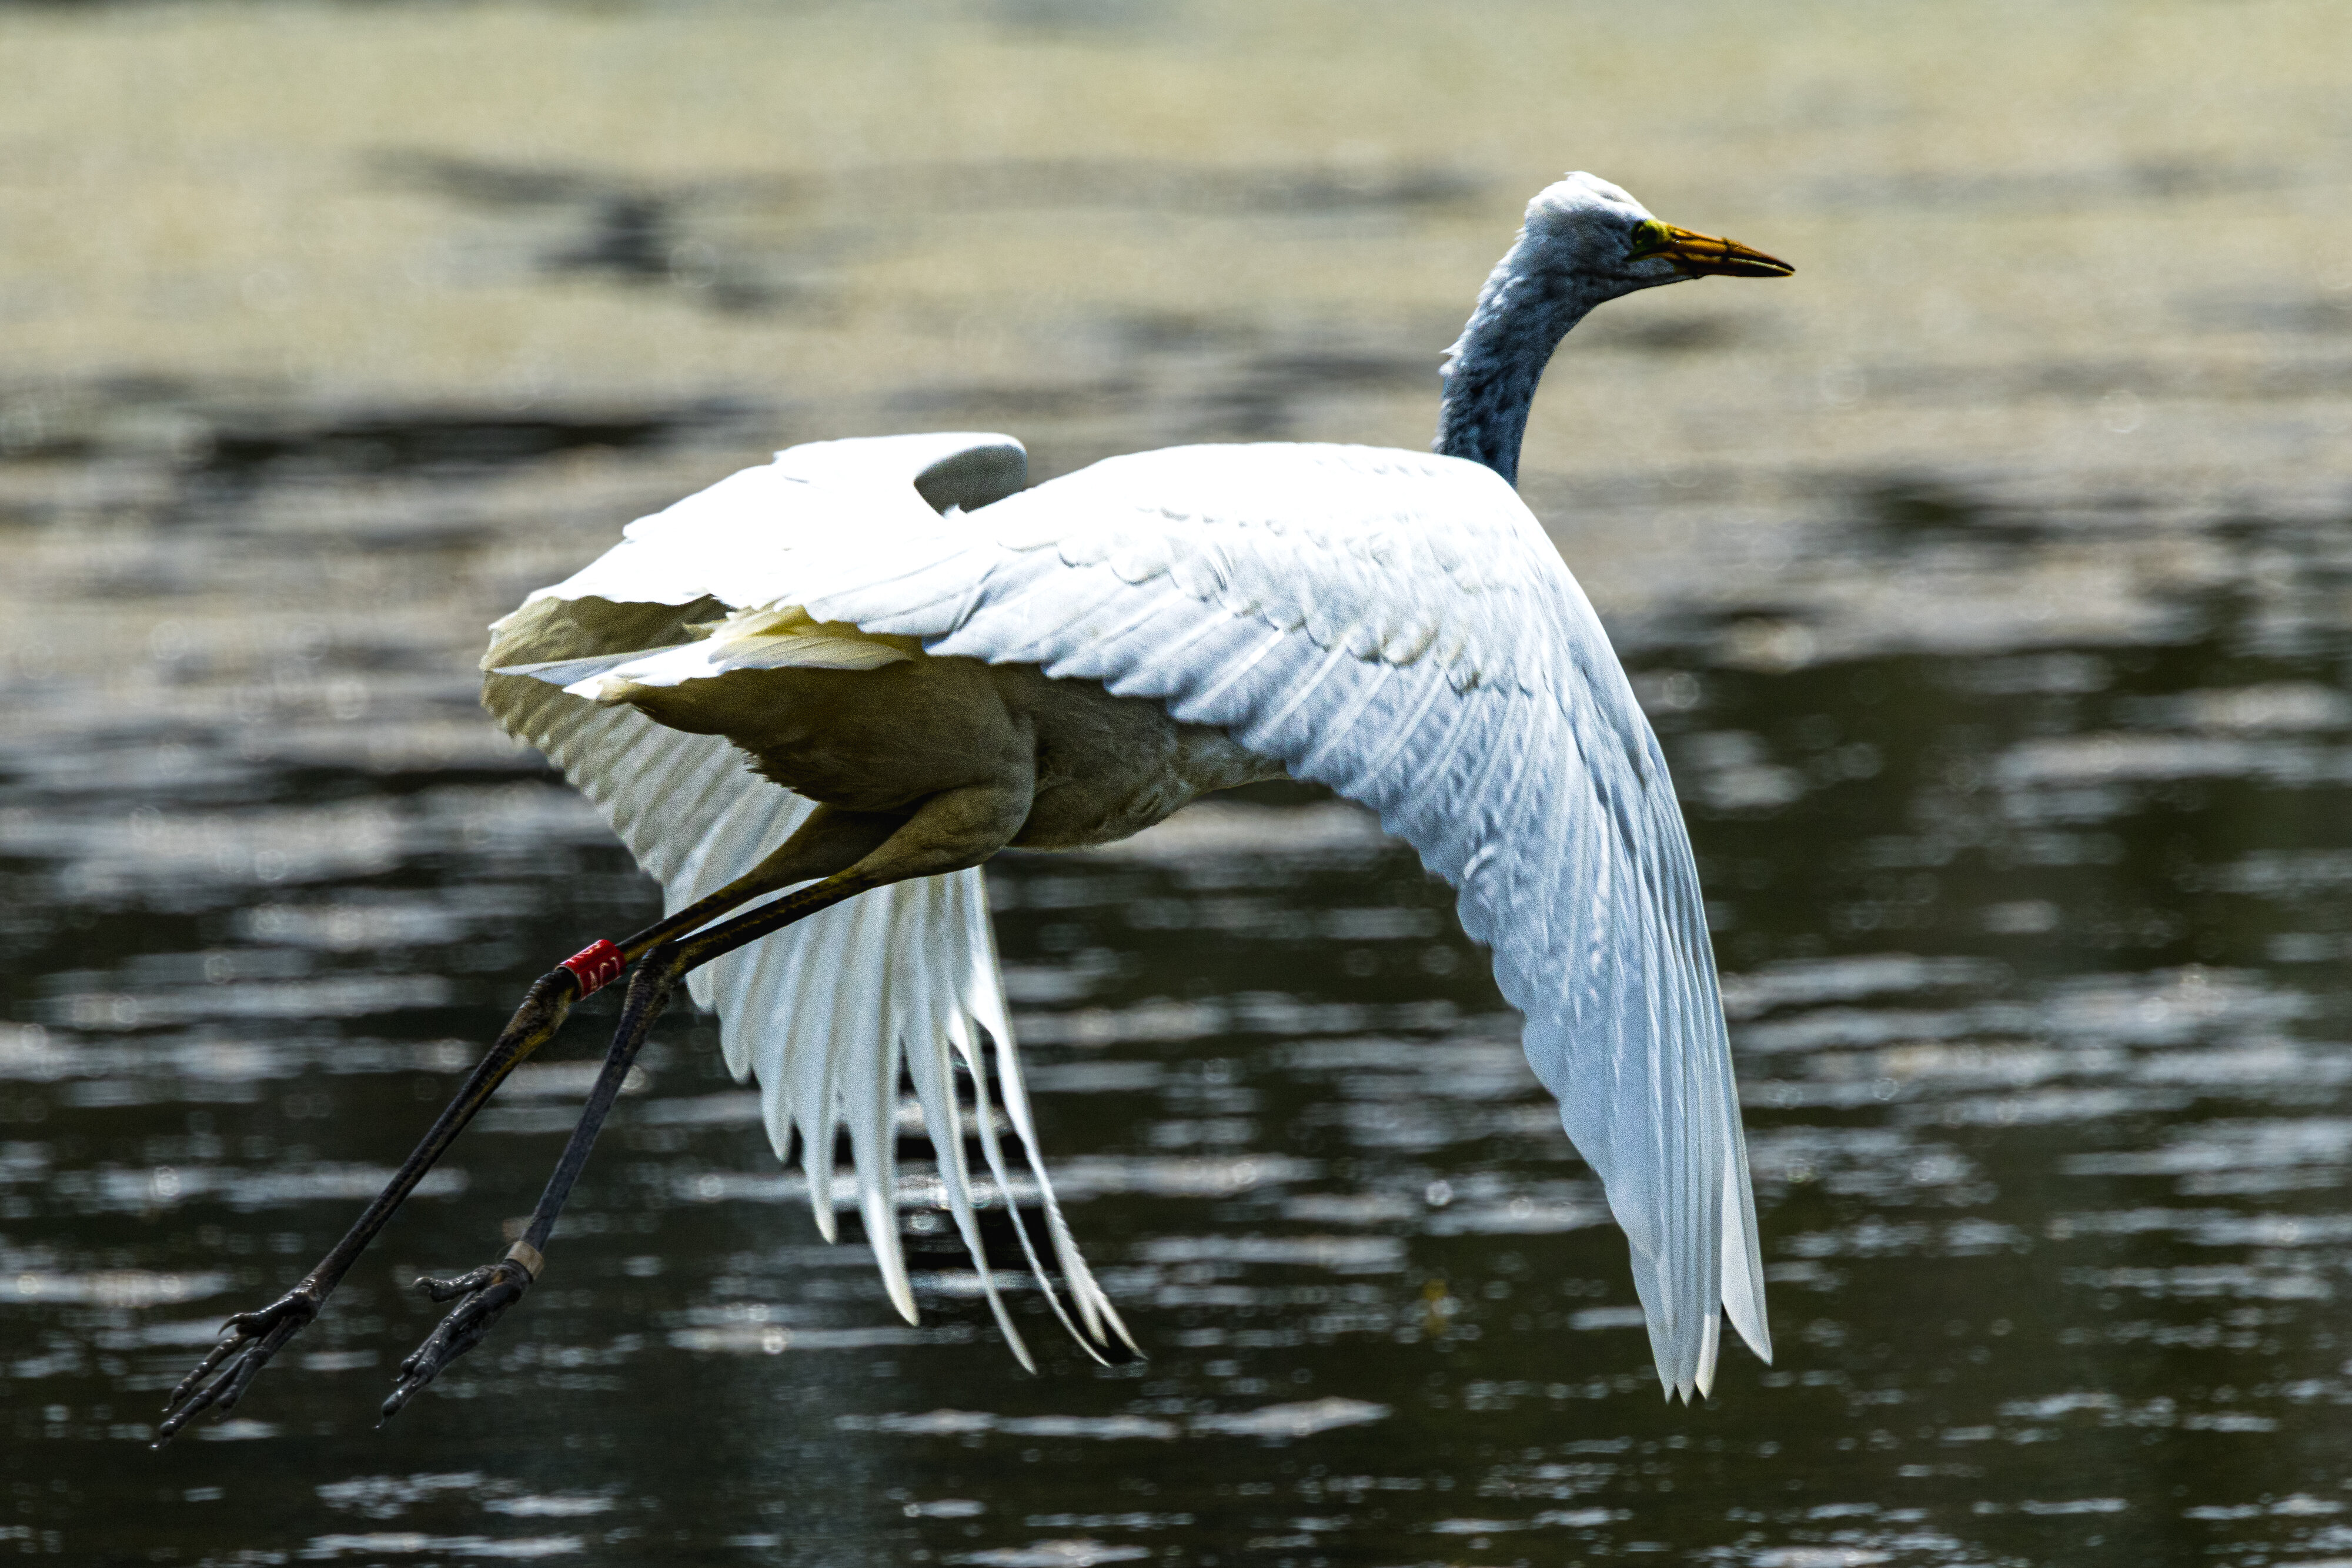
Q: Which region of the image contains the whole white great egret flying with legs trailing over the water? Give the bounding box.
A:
[160,174,1790,1439]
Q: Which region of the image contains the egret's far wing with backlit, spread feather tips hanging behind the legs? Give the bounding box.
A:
[482,437,1127,1363]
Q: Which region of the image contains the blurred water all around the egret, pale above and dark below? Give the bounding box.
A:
[0,0,2352,1568]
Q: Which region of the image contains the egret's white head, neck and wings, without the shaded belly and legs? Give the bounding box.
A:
[485,176,1788,1396]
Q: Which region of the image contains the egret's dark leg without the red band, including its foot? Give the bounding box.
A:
[383,778,1028,1420]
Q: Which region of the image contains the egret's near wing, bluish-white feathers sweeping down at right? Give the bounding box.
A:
[781,444,1771,1396]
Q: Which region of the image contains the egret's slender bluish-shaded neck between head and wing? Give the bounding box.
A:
[1435,233,1606,484]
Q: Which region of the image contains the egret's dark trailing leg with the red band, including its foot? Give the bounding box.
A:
[155,808,898,1446]
